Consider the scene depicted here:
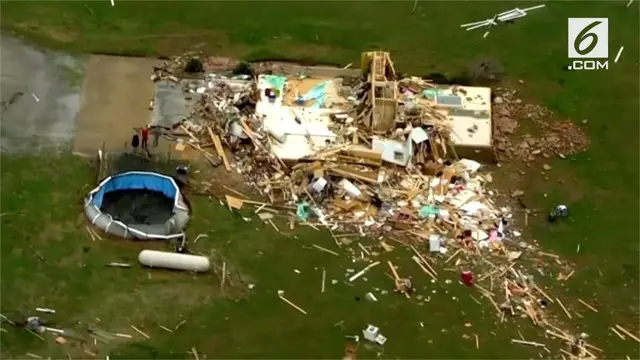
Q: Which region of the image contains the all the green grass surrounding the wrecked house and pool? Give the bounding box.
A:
[0,0,640,358]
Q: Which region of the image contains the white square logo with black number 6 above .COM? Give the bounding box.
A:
[568,18,609,59]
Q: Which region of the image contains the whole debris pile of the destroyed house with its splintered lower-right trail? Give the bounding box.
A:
[149,52,608,358]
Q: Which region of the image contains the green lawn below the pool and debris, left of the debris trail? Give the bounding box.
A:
[1,156,538,359]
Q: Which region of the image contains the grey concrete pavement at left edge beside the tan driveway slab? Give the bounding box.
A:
[0,33,85,153]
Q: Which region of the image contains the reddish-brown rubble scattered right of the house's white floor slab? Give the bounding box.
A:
[493,88,589,161]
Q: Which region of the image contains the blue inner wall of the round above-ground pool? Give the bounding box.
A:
[91,172,178,209]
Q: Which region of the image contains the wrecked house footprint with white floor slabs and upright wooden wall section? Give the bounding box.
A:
[152,51,491,171]
